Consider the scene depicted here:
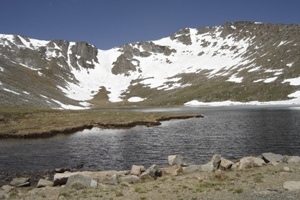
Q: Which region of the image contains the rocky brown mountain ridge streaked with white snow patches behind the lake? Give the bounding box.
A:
[0,22,300,109]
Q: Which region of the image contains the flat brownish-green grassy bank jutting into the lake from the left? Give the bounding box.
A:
[0,107,201,138]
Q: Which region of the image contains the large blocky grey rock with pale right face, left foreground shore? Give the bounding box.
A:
[66,174,98,189]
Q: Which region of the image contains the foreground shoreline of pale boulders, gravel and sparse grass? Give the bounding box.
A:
[0,153,300,199]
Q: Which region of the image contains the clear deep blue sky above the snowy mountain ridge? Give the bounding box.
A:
[0,0,300,50]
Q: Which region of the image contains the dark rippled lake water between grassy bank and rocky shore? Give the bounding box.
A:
[0,106,300,172]
